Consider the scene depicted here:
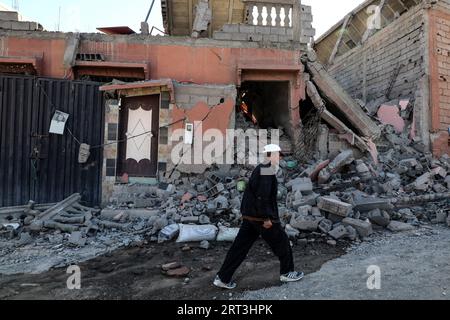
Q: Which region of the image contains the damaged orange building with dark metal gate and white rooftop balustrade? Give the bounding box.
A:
[0,0,378,205]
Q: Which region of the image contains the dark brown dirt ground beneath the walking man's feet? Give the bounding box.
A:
[0,241,346,300]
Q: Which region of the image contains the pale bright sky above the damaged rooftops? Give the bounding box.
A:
[0,0,363,37]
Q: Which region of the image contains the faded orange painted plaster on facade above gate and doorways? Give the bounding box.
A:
[0,33,305,140]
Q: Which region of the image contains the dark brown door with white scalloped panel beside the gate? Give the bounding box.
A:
[118,95,160,177]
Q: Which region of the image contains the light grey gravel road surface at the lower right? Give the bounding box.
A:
[239,226,450,300]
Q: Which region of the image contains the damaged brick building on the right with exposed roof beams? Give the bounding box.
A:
[314,0,450,156]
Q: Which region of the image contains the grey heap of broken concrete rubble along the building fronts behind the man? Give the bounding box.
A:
[0,112,450,276]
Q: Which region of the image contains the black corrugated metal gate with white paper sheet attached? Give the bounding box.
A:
[0,75,104,207]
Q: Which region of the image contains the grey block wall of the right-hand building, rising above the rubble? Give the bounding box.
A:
[322,5,430,149]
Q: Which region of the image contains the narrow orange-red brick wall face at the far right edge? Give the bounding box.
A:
[429,8,450,156]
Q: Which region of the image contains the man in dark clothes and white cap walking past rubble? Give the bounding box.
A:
[214,144,304,290]
